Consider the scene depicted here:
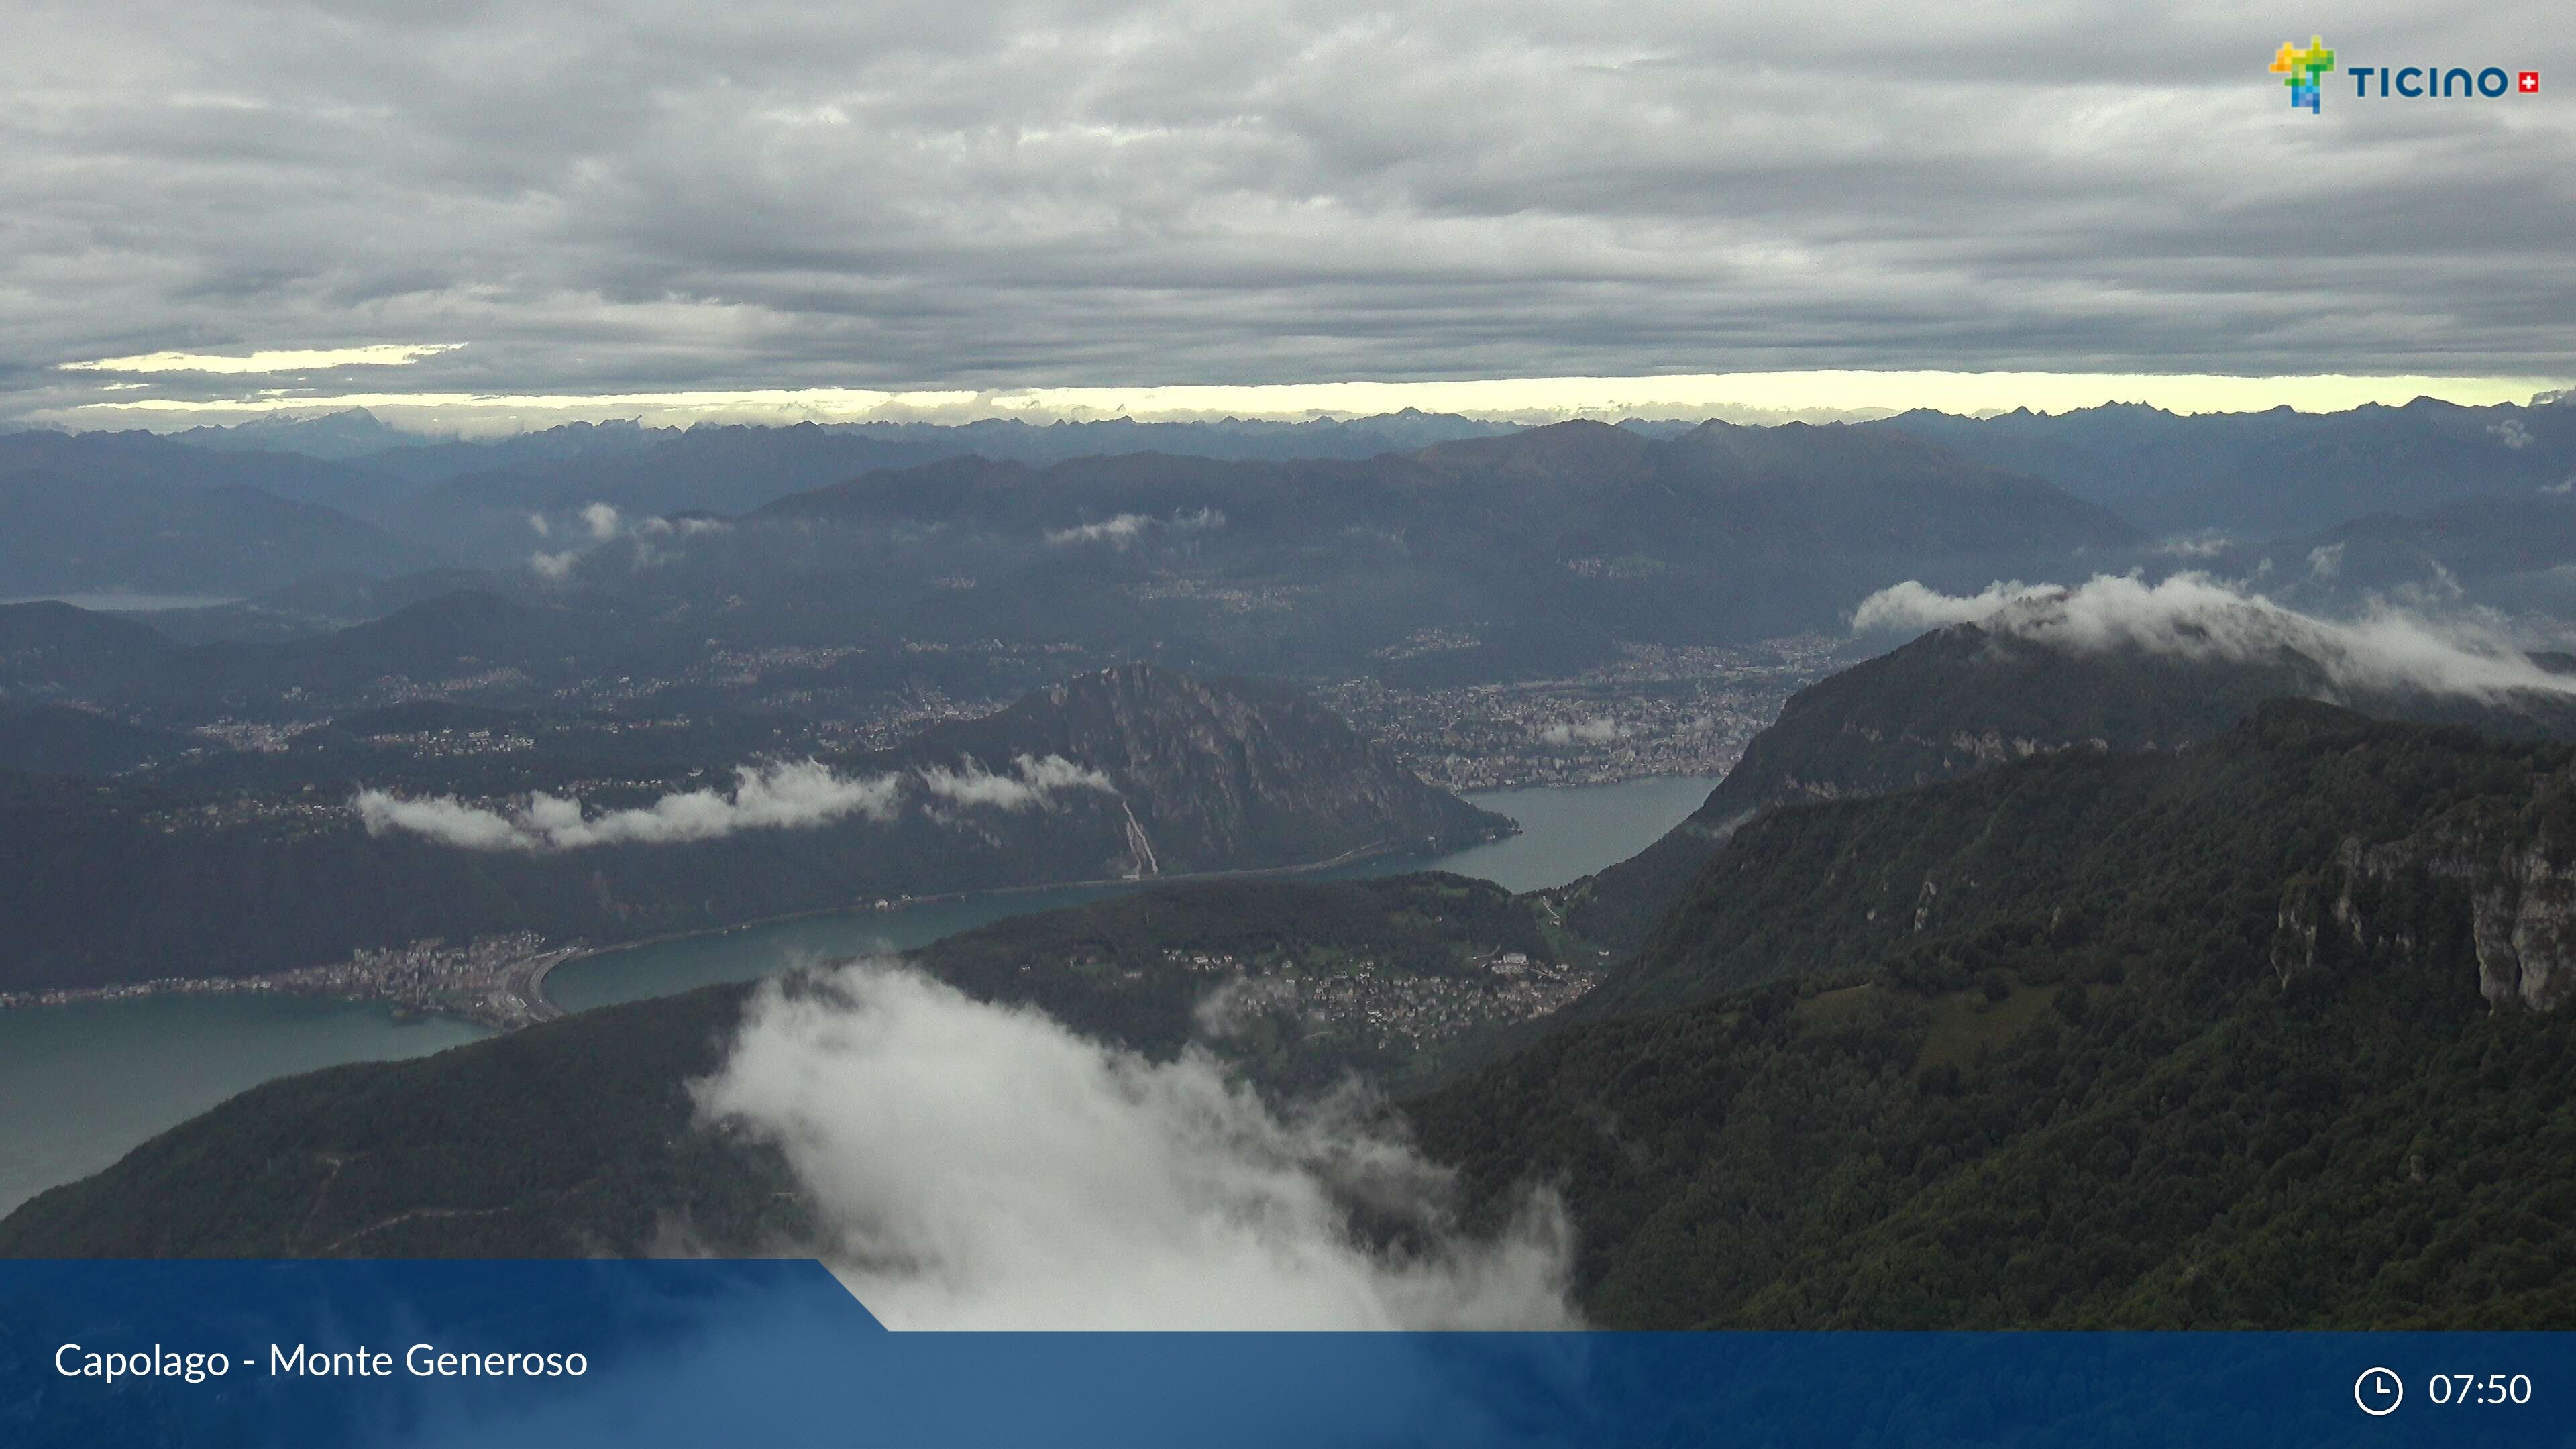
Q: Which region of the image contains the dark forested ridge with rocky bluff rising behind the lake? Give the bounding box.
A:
[0,659,1512,990]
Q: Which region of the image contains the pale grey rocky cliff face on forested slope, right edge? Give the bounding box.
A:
[2272,782,2576,1011]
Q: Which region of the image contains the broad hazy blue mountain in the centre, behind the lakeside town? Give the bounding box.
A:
[592,412,2135,684]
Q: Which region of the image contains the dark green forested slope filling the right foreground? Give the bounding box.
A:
[1414,701,2576,1328]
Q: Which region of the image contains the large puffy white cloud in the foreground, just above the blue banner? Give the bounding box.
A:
[696,962,1576,1328]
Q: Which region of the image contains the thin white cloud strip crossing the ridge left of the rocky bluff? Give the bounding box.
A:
[350,755,1118,851]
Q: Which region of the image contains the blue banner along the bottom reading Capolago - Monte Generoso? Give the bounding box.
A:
[0,1260,2576,1449]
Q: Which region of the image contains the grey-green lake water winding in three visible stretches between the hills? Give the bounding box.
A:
[0,779,1715,1214]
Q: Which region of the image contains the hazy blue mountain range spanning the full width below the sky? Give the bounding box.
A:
[20,402,2576,678]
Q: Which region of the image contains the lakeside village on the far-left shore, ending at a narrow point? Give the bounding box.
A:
[0,930,585,1031]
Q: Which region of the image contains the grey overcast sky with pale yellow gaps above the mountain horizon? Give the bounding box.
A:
[0,0,2576,423]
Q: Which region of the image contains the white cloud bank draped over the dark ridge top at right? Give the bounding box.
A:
[1852,572,2576,699]
